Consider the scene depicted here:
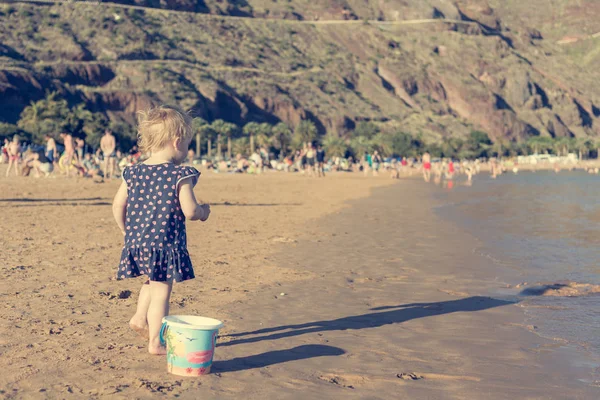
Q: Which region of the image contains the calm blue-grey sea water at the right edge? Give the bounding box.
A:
[437,172,600,360]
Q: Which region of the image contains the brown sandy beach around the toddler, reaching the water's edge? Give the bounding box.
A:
[0,170,599,399]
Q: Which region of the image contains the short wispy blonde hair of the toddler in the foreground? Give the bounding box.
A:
[138,105,194,153]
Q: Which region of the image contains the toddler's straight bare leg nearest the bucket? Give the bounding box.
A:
[148,281,173,355]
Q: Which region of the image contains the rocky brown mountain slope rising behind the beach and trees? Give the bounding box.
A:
[0,0,600,140]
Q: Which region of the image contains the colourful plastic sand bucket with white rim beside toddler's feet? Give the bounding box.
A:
[160,315,223,376]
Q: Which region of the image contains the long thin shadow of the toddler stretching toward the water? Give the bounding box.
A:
[219,296,514,347]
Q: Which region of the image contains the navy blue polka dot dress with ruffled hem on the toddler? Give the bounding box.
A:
[117,163,200,282]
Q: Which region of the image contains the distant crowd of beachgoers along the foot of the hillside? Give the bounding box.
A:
[0,130,558,185]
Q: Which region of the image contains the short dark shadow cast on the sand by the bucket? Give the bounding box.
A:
[213,344,346,372]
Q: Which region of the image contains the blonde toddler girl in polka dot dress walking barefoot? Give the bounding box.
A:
[113,106,210,354]
